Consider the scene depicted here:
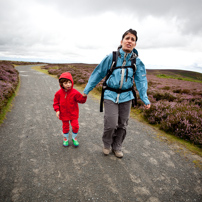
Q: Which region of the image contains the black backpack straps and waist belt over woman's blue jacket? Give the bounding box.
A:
[100,51,137,112]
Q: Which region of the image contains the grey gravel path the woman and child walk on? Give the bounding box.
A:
[0,66,202,202]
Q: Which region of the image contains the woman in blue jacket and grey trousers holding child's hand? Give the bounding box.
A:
[84,29,150,158]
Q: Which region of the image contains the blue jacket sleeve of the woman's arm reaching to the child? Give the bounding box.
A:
[84,53,112,95]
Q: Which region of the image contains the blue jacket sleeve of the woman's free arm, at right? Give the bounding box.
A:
[134,58,150,105]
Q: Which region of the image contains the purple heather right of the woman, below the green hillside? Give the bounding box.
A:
[141,75,202,147]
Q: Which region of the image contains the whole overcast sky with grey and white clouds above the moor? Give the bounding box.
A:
[0,0,202,73]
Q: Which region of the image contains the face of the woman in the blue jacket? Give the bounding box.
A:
[121,33,136,53]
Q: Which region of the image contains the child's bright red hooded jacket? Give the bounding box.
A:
[53,72,87,121]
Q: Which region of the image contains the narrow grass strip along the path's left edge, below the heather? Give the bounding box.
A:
[0,79,20,125]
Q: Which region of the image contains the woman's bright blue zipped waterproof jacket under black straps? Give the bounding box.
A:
[84,49,150,105]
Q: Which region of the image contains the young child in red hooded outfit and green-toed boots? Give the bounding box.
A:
[53,72,87,147]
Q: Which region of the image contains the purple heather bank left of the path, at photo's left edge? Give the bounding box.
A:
[0,61,19,113]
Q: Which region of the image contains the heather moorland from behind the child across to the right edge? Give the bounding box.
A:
[43,64,202,147]
